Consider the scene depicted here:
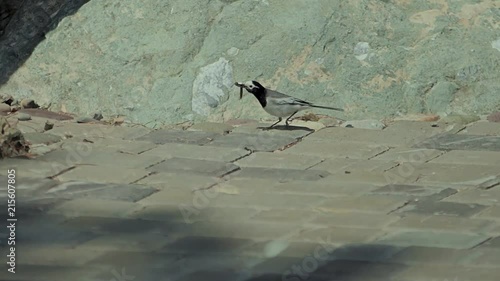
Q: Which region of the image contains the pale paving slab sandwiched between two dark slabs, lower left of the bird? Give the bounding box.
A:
[141,143,250,162]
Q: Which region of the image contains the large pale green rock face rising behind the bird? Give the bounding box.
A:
[0,0,500,126]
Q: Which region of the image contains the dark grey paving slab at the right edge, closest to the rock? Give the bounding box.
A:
[414,134,500,151]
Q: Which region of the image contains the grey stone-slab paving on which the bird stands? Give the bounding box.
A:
[0,114,500,281]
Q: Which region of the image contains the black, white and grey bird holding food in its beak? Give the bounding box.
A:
[234,81,344,129]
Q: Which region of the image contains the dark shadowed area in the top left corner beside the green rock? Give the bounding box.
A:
[0,0,90,85]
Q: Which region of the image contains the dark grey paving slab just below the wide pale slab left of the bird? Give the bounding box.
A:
[147,157,240,177]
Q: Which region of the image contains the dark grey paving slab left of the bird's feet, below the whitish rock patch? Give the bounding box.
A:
[136,129,220,145]
